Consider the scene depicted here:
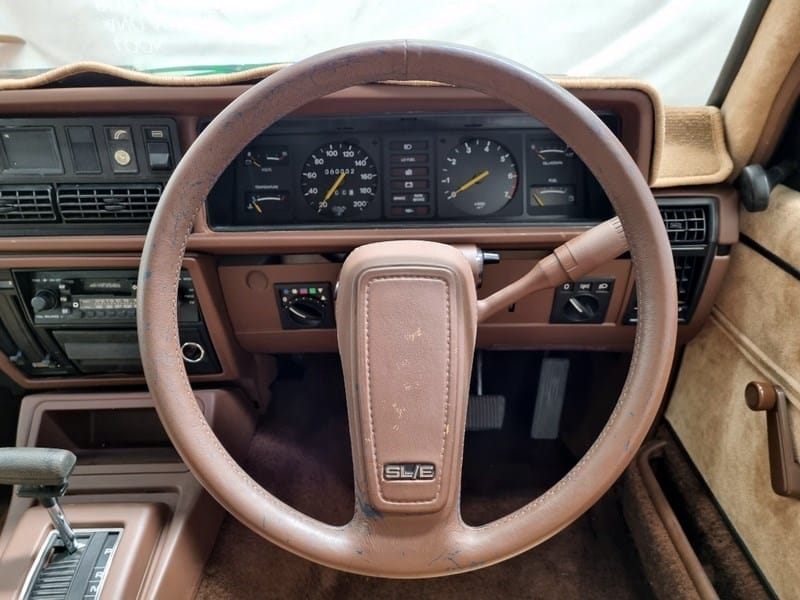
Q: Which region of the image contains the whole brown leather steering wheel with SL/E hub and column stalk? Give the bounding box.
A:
[138,40,677,578]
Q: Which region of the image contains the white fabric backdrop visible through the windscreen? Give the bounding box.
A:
[0,0,747,104]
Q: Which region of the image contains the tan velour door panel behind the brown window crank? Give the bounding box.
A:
[667,186,800,598]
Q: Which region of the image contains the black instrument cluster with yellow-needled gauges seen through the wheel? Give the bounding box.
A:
[203,113,618,229]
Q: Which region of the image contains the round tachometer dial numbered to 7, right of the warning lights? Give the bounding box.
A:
[439,138,519,215]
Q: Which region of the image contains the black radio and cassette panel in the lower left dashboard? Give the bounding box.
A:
[0,269,220,377]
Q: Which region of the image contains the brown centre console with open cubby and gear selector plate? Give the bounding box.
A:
[0,389,255,599]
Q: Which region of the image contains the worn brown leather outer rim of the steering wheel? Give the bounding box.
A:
[138,41,677,577]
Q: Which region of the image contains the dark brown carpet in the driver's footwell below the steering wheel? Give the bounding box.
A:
[197,357,651,600]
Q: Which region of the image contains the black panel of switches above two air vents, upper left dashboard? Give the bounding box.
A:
[0,115,180,237]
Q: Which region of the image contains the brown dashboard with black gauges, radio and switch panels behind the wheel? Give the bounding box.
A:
[0,85,738,395]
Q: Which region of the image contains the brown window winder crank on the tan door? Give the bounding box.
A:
[744,381,800,498]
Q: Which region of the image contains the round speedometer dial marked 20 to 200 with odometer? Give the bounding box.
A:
[300,142,378,218]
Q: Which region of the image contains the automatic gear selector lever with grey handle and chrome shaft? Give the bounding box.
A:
[0,448,78,554]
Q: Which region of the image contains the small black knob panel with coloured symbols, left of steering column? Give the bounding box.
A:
[275,283,334,329]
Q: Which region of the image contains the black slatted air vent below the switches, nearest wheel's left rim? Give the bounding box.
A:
[57,184,161,223]
